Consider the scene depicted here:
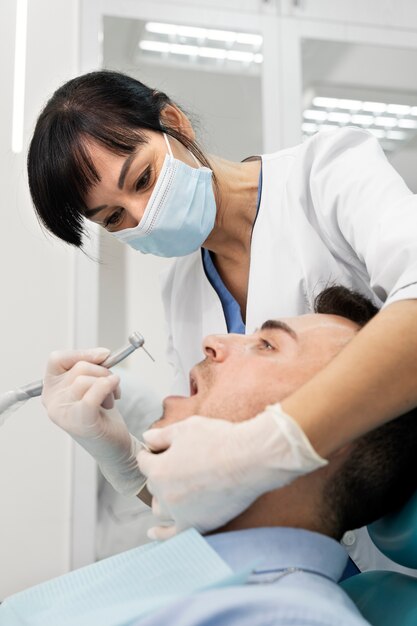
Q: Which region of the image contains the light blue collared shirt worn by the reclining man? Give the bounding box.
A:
[136,528,369,626]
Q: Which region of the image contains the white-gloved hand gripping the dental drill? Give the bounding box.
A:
[42,348,146,496]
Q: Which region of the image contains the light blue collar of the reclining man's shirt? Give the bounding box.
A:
[205,527,348,582]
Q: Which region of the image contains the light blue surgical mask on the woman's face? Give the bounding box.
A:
[112,133,216,257]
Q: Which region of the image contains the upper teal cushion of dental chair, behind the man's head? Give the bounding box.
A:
[368,493,417,568]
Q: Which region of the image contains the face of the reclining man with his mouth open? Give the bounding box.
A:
[156,314,358,426]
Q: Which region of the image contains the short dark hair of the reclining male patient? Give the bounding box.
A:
[315,286,417,539]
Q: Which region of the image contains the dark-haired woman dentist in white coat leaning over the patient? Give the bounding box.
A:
[28,71,417,560]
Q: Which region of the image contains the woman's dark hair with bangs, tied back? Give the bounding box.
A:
[27,70,210,247]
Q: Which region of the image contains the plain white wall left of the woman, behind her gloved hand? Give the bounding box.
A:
[0,0,78,599]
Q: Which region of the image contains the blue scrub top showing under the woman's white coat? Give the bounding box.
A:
[201,161,262,335]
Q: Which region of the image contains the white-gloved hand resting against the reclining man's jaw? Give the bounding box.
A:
[138,404,327,539]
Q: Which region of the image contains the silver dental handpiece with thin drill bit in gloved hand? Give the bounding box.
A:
[0,331,155,424]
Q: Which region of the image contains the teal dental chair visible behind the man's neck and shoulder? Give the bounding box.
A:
[341,493,417,626]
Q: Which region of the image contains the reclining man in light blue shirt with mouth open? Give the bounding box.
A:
[39,287,417,626]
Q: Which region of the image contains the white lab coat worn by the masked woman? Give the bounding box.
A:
[162,128,417,572]
